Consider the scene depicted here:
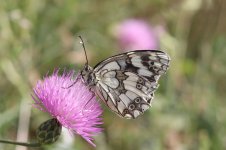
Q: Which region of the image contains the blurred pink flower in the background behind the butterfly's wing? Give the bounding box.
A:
[117,19,159,51]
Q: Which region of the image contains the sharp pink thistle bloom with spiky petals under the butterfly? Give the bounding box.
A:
[32,70,102,146]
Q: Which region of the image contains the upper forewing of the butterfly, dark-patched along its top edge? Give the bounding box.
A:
[94,50,170,82]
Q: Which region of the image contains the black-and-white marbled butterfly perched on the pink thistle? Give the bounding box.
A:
[79,36,170,119]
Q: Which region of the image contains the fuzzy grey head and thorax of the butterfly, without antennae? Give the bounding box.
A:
[81,64,95,86]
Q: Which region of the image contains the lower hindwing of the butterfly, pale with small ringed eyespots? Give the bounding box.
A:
[96,70,158,118]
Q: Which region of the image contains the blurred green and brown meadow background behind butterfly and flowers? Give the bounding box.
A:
[0,0,226,150]
